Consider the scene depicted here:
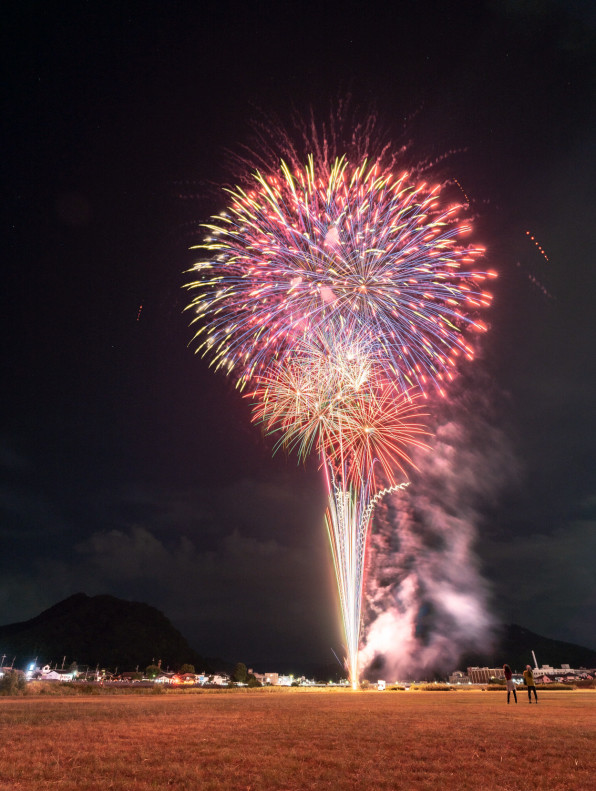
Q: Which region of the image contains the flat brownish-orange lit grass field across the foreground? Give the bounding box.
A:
[0,689,596,791]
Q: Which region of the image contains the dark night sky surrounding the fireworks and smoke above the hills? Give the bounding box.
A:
[0,0,596,671]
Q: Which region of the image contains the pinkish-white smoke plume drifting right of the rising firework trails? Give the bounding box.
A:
[360,388,517,680]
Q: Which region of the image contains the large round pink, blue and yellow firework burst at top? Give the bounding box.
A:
[189,157,493,392]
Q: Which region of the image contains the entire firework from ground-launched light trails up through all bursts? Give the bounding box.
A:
[188,150,495,686]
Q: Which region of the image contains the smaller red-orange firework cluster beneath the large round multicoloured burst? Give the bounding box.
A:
[248,324,426,488]
